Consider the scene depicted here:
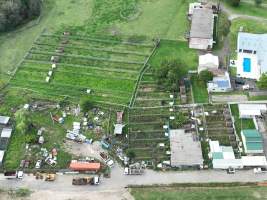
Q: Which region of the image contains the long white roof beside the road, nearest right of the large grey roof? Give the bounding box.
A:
[212,159,243,169]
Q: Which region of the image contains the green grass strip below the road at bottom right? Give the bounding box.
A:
[131,186,267,200]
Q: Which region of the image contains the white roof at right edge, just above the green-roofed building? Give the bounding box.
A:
[238,104,267,117]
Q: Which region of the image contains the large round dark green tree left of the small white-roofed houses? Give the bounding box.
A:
[153,60,188,91]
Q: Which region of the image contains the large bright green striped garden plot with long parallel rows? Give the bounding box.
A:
[10,32,154,106]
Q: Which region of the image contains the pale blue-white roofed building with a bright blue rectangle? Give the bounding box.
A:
[236,32,267,80]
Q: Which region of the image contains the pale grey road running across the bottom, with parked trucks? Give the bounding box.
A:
[0,165,267,199]
